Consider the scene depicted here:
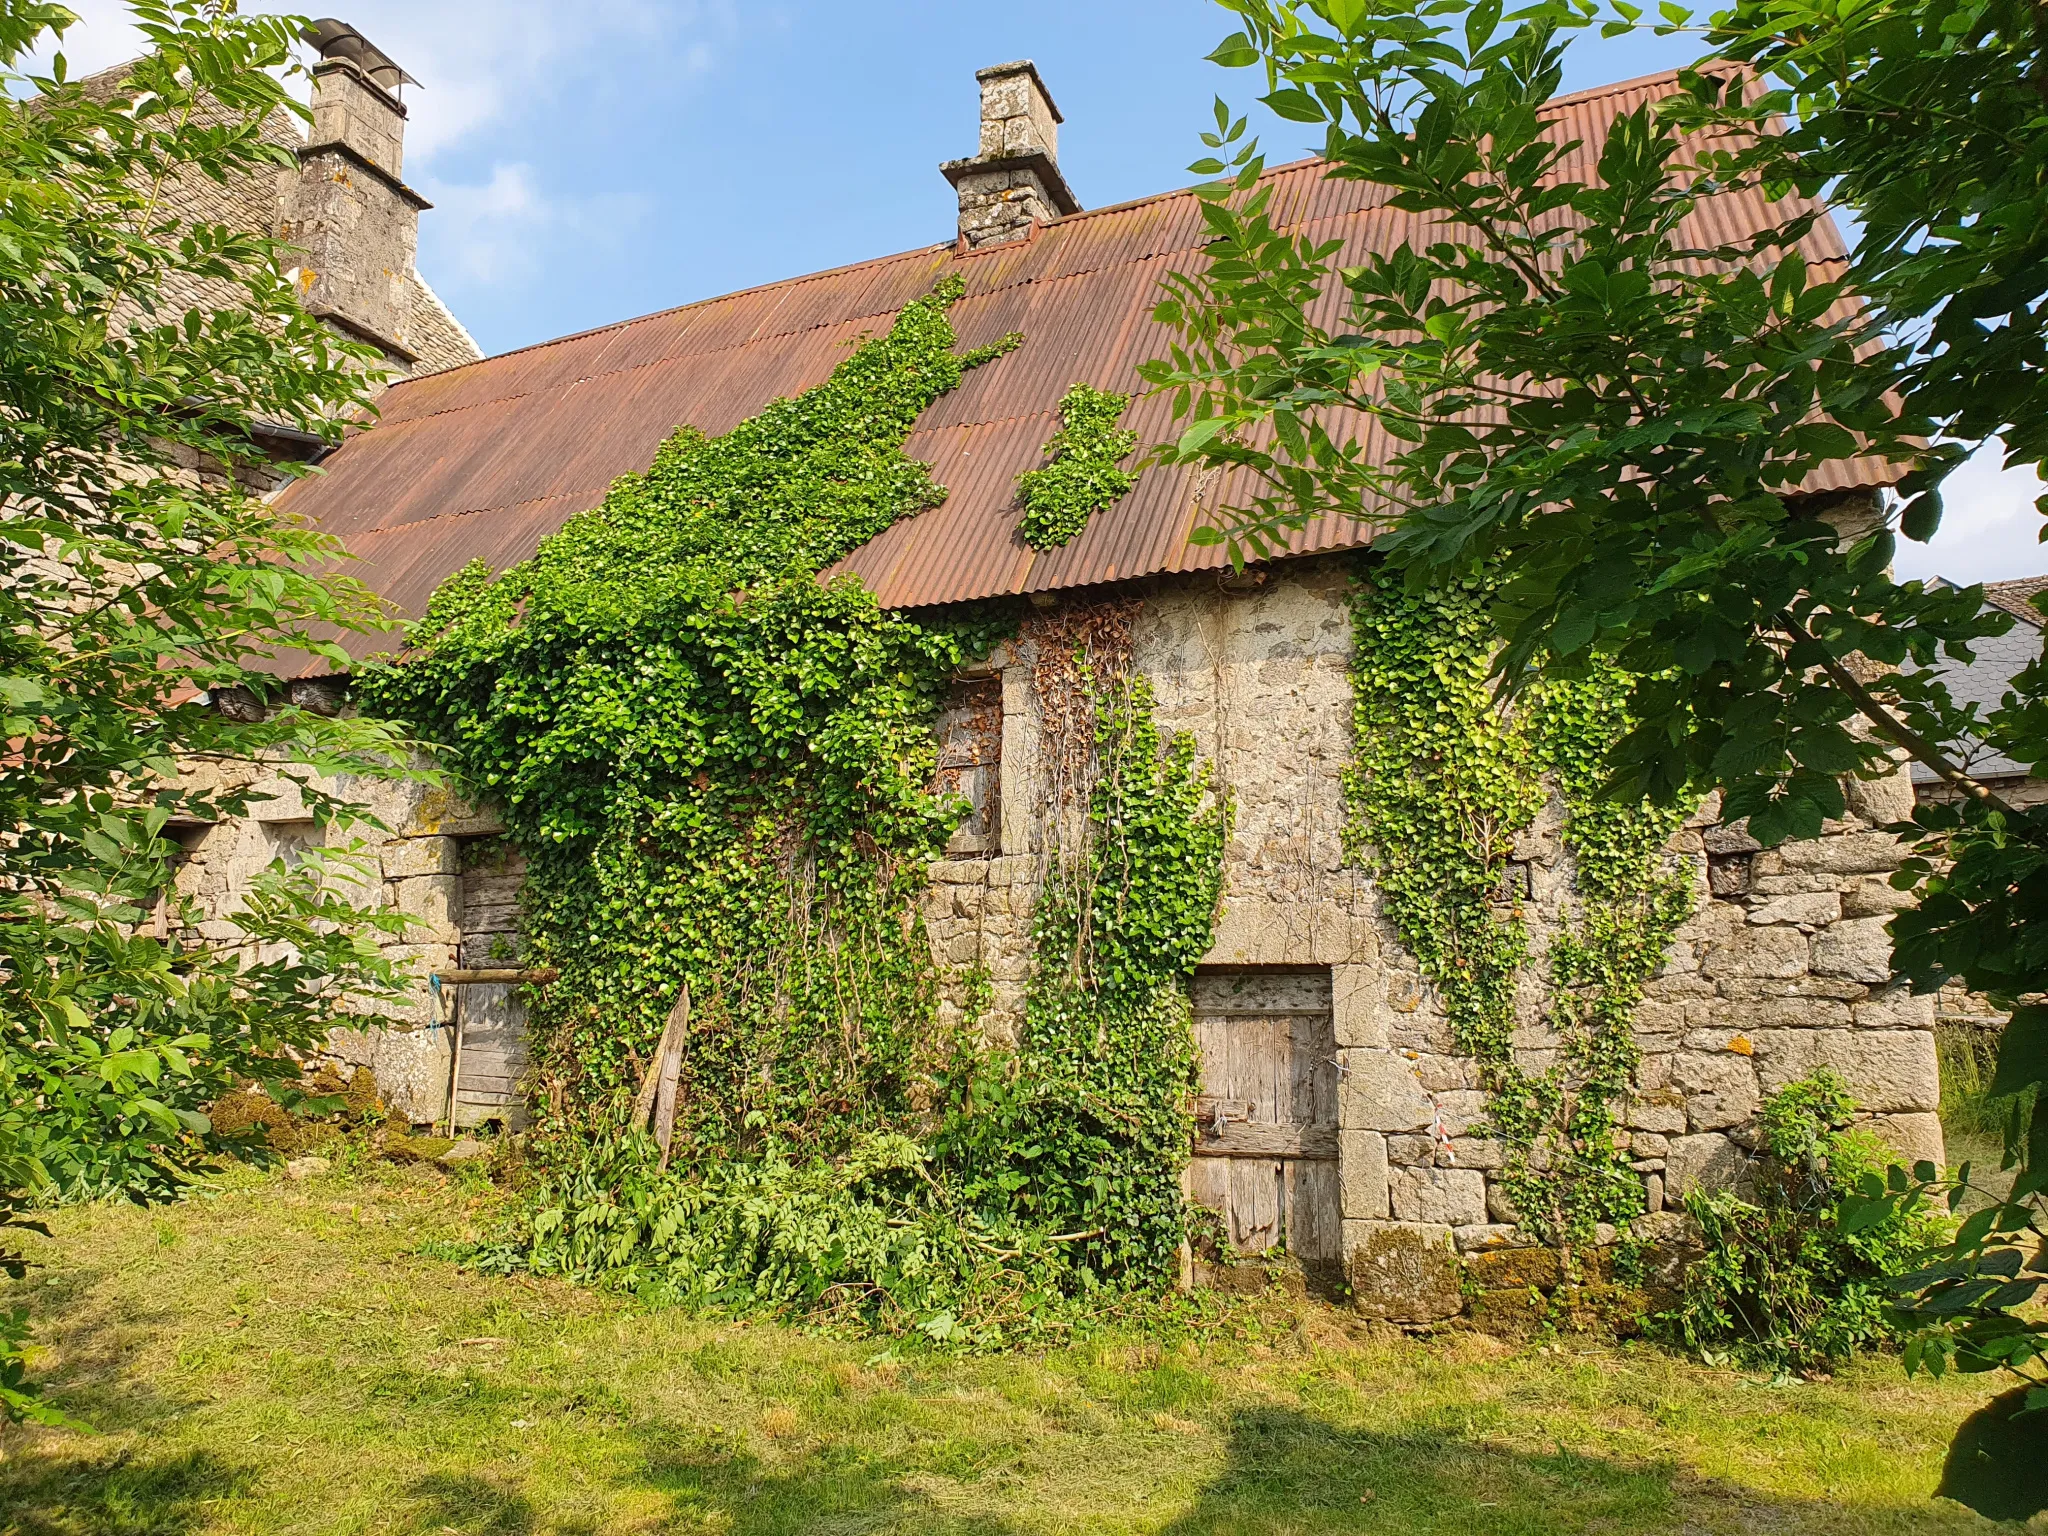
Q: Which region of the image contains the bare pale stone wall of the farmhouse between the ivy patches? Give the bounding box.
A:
[178,557,1942,1321]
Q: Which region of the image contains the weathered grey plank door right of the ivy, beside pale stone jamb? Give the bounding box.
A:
[1190,971,1343,1268]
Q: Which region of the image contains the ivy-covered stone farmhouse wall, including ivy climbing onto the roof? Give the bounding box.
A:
[167,287,1937,1339]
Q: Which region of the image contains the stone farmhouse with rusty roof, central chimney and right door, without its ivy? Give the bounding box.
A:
[182,63,1942,1321]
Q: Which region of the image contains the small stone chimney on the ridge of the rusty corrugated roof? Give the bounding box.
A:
[940,59,1081,252]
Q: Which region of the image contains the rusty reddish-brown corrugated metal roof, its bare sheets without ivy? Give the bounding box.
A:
[287,74,1894,649]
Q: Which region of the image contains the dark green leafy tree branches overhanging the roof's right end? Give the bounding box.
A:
[1147,0,2048,1515]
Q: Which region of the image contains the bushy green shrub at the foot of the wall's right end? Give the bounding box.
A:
[1657,1069,1944,1370]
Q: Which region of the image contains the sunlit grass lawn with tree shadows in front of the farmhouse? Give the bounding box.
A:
[0,1169,1993,1536]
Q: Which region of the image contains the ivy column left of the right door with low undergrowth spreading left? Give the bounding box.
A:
[479,680,1229,1348]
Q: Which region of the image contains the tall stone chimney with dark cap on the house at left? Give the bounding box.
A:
[285,16,432,365]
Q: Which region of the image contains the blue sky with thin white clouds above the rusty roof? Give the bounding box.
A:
[39,0,2048,580]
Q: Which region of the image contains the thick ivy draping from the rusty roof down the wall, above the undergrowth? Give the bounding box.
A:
[365,281,1014,1155]
